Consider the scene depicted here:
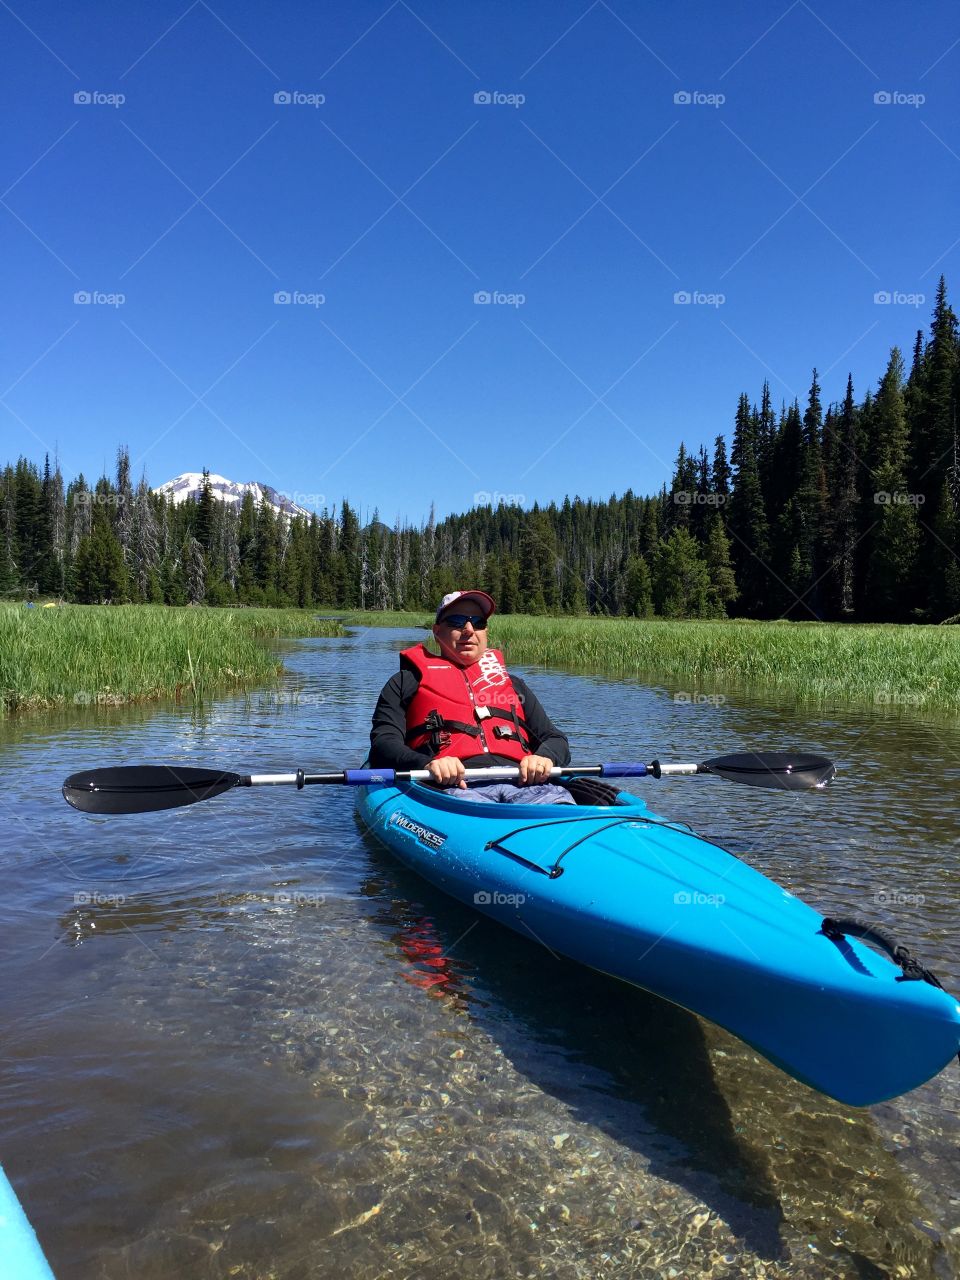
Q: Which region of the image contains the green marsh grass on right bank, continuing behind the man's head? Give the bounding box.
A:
[343,613,960,713]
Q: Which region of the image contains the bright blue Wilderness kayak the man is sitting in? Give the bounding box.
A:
[357,782,960,1106]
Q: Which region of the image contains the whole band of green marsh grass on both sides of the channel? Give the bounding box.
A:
[0,604,960,714]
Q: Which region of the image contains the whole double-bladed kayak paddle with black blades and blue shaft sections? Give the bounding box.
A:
[63,751,836,814]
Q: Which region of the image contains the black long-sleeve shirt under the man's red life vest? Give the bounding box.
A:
[370,667,570,769]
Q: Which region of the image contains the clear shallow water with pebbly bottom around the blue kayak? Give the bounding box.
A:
[0,630,960,1280]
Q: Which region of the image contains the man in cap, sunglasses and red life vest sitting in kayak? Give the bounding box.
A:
[370,591,575,804]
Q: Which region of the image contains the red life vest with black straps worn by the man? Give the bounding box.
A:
[401,644,530,760]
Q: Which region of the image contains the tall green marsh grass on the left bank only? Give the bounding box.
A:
[0,604,343,716]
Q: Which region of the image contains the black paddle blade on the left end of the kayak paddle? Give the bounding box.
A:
[63,764,241,813]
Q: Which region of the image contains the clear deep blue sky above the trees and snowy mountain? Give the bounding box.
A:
[0,0,960,521]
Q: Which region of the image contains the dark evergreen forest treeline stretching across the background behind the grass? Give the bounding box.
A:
[0,279,960,622]
